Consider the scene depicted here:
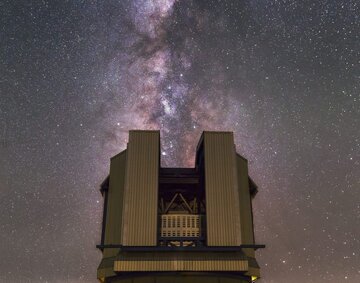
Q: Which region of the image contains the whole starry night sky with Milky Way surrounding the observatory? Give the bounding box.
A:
[0,0,360,283]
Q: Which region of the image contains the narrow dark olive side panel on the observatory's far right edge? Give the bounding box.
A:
[237,155,255,257]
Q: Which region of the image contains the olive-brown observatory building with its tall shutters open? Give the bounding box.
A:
[97,131,264,283]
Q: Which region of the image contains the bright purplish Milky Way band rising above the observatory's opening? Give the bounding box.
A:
[100,1,256,166]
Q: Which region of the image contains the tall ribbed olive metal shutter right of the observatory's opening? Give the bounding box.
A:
[203,132,241,246]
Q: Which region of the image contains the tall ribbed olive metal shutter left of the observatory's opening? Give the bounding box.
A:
[122,131,160,246]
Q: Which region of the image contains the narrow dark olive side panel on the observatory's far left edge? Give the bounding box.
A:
[103,150,127,258]
